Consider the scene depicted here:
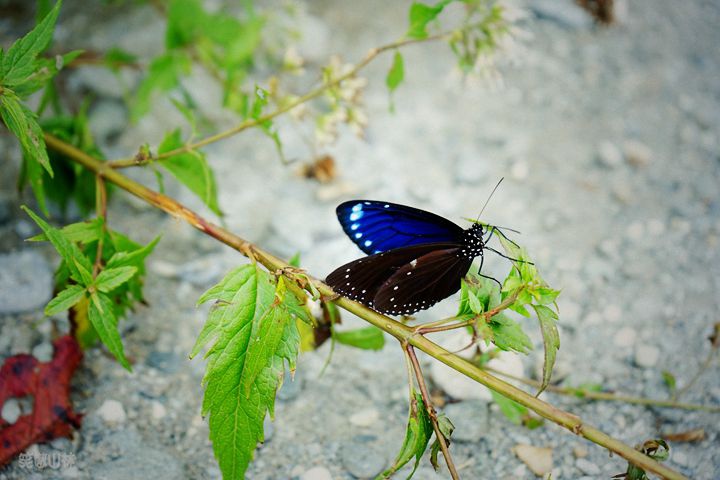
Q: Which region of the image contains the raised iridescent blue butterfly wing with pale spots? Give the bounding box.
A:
[336,200,463,255]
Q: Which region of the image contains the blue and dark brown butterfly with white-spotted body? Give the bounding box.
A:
[325,199,514,315]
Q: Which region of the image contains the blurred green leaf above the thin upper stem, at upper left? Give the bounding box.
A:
[130,51,192,122]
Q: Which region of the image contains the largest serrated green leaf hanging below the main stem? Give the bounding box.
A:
[191,265,300,478]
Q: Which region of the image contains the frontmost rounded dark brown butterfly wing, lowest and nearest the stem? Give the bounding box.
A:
[373,246,472,315]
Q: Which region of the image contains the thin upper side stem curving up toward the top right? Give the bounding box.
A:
[108,29,456,168]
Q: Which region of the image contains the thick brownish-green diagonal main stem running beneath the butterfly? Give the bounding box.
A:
[45,134,687,480]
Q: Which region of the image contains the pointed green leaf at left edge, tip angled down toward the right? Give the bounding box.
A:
[0,90,53,177]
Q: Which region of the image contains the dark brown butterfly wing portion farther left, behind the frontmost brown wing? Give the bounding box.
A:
[325,243,462,307]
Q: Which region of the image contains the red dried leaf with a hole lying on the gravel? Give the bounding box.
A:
[0,335,82,466]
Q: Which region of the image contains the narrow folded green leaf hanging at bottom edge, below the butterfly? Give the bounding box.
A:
[377,390,433,479]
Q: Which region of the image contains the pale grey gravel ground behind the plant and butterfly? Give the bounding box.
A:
[0,0,720,480]
